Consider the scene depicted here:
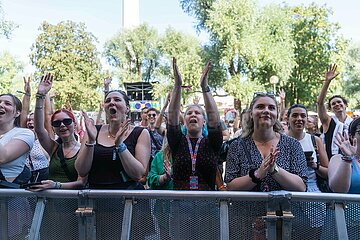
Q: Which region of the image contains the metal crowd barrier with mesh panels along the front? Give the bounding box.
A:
[0,189,360,240]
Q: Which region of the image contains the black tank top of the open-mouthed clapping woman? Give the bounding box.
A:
[89,125,144,189]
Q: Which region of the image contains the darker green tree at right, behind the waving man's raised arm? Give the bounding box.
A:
[284,3,347,107]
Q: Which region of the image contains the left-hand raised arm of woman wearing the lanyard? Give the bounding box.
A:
[168,58,182,126]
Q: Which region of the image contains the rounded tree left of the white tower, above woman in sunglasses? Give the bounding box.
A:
[30,21,102,110]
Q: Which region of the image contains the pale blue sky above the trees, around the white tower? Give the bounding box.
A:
[0,0,360,71]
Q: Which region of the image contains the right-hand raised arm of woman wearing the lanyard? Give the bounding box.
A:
[200,61,220,127]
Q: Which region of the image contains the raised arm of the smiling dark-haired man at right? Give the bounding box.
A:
[316,64,339,132]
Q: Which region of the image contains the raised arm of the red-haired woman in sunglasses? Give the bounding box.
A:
[34,73,56,155]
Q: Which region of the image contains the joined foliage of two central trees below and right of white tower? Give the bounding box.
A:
[104,24,205,103]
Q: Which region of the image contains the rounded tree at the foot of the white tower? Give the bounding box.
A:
[104,24,159,82]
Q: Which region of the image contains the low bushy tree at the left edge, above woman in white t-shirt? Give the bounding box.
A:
[0,52,24,93]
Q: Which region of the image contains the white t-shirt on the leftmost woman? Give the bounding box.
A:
[0,127,35,178]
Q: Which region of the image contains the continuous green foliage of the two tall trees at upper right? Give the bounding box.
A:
[180,0,347,109]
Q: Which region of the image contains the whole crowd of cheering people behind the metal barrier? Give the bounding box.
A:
[0,58,360,238]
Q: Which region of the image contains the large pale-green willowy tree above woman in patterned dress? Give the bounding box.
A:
[181,0,295,108]
